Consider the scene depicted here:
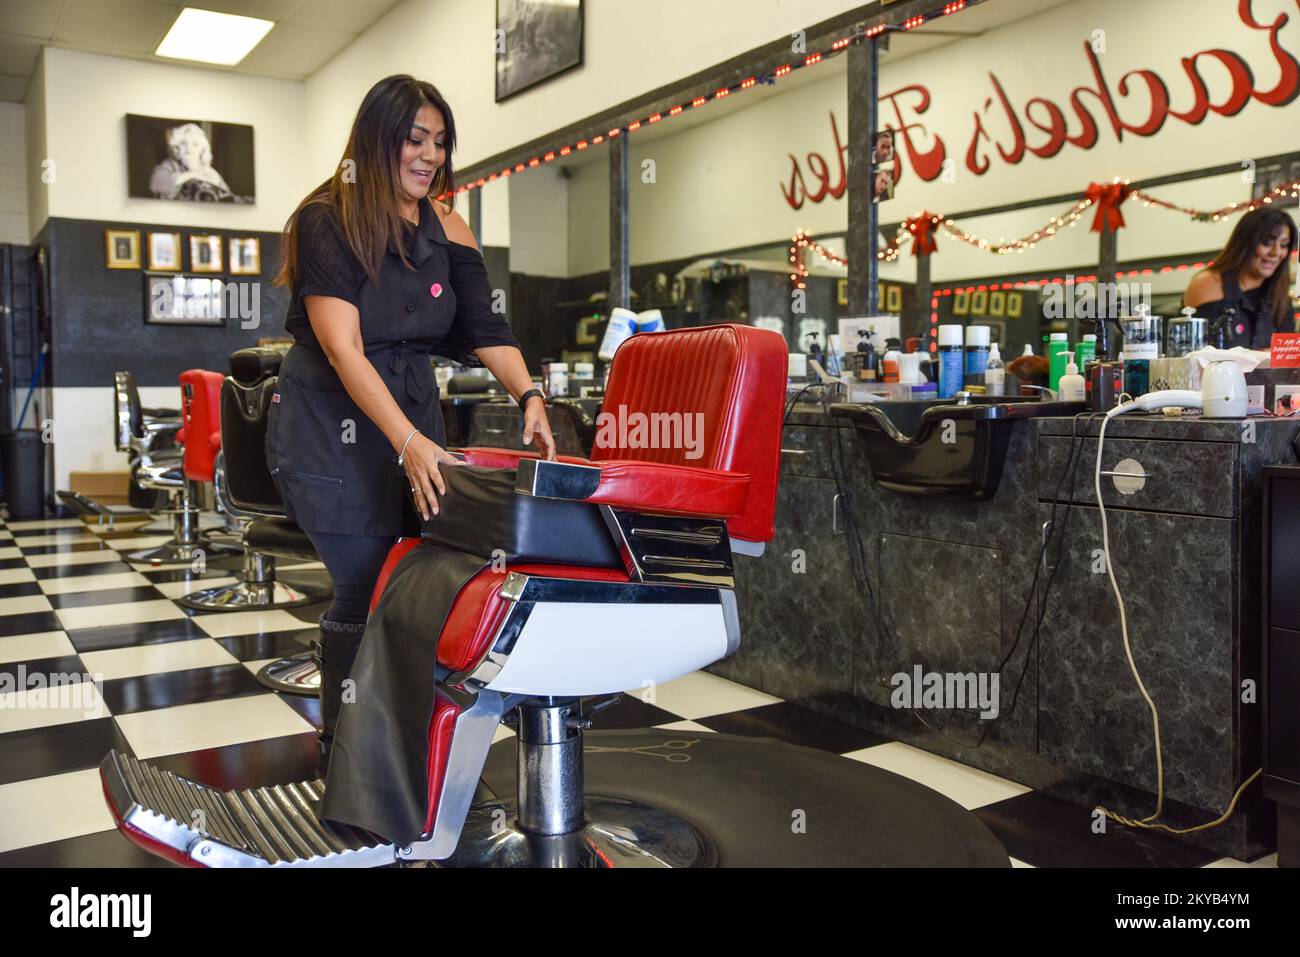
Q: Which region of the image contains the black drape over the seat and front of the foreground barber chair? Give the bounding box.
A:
[321,465,623,845]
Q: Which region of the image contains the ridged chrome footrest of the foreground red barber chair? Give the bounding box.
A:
[99,750,397,867]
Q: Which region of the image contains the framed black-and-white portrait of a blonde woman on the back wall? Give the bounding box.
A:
[126,113,257,203]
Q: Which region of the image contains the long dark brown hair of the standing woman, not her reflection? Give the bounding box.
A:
[276,74,456,286]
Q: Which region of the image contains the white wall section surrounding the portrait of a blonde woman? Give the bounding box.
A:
[37,47,312,234]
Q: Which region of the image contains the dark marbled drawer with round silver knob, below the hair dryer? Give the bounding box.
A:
[1037,436,1238,519]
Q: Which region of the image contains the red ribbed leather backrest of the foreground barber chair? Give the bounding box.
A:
[592,324,788,542]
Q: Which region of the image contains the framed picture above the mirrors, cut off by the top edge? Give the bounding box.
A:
[497,0,582,103]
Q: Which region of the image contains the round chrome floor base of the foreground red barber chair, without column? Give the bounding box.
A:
[436,794,718,869]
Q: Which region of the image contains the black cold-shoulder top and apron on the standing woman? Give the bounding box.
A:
[267,200,519,536]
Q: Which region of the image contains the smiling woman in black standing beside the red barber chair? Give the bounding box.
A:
[267,75,555,759]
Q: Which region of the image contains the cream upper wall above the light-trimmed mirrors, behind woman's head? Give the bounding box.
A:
[307,0,863,179]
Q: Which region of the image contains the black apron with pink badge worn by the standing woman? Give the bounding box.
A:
[267,203,456,537]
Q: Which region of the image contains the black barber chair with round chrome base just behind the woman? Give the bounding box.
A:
[179,348,332,613]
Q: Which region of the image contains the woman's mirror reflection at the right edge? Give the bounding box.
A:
[1183,207,1296,348]
